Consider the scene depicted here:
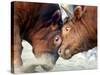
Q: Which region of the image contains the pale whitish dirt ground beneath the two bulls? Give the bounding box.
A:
[15,41,97,73]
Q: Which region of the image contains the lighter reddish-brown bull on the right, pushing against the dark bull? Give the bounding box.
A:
[58,6,97,59]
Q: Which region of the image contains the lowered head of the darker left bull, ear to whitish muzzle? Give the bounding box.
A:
[31,10,62,71]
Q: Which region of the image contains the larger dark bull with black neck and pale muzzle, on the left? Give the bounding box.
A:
[11,2,62,72]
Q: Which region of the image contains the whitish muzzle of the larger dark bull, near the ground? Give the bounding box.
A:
[37,53,58,71]
